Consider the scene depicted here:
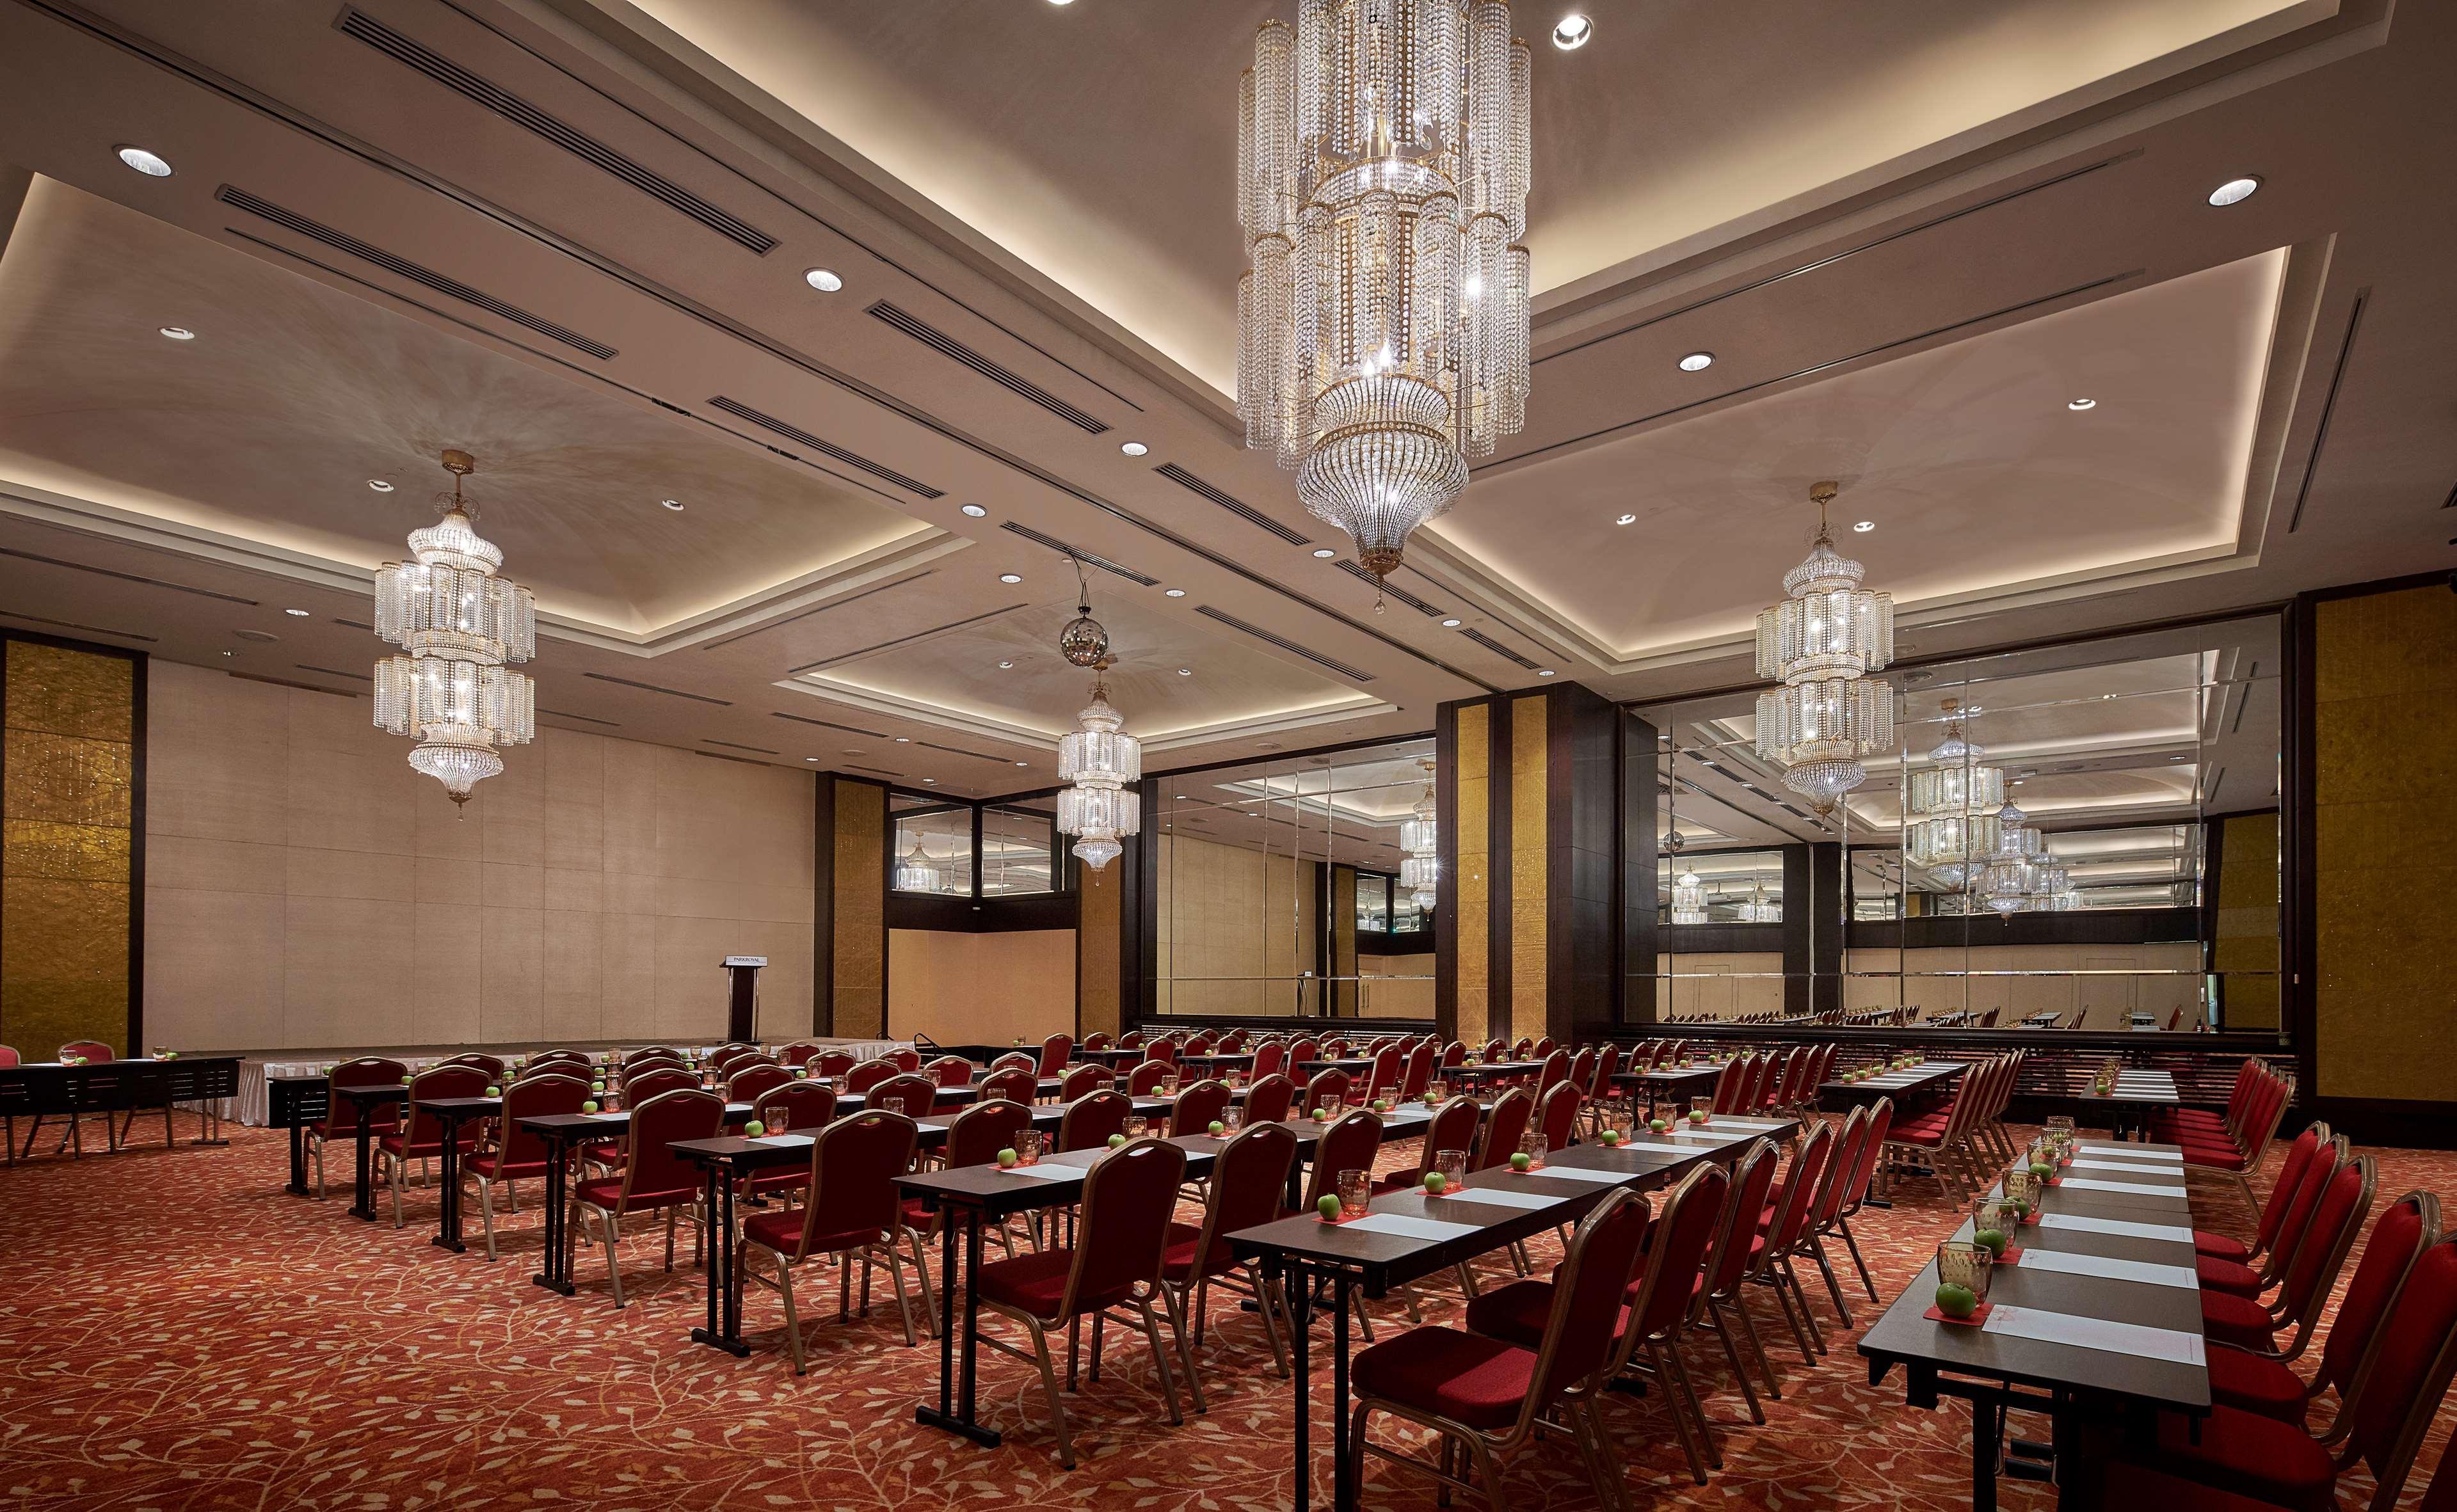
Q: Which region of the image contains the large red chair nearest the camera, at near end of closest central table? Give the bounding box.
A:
[1349,1190,1646,1509]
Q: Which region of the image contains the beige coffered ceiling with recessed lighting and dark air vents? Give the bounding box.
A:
[0,0,2457,805]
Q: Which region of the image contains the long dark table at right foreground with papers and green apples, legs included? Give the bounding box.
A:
[1860,1139,2209,1512]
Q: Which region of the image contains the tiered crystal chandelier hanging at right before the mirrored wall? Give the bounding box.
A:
[1757,484,1894,815]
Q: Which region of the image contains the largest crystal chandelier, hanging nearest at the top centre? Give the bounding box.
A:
[1236,0,1531,579]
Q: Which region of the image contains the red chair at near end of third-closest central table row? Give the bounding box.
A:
[742,1110,931,1374]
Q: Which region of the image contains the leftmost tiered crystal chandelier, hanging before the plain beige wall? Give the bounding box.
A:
[376,452,538,805]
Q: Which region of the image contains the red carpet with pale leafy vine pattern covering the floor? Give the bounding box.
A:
[0,1114,2457,1512]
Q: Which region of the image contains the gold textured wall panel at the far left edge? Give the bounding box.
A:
[0,641,133,1060]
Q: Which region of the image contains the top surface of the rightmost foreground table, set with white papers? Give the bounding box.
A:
[1860,1142,2209,1412]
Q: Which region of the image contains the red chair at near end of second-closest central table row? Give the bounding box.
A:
[973,1138,1187,1470]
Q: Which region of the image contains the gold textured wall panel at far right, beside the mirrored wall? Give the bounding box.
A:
[2309,584,2457,1102]
